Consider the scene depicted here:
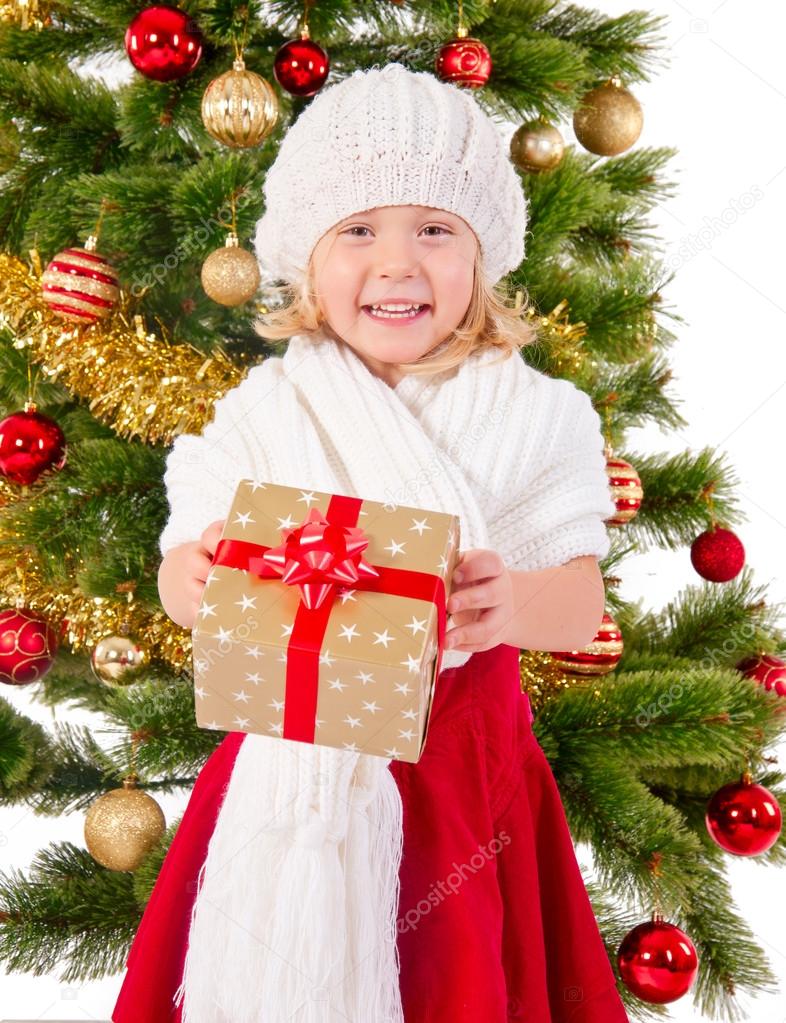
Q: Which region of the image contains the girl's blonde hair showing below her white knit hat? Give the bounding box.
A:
[254,246,537,375]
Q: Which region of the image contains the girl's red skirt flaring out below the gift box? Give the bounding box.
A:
[112,644,627,1023]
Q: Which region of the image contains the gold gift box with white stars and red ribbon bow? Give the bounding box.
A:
[192,480,460,763]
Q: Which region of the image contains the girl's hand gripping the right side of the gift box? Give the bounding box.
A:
[445,548,513,654]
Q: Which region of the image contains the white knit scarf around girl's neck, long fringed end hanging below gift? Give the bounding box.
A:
[175,337,532,1023]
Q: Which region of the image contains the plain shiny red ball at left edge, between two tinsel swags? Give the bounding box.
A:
[0,401,66,486]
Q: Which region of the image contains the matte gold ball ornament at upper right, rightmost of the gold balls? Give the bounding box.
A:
[573,76,644,157]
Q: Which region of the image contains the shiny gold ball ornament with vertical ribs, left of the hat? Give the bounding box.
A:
[202,56,278,149]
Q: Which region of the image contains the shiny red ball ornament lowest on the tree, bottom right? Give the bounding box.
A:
[617,913,699,1005]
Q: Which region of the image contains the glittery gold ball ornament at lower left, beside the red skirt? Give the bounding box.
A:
[85,774,167,871]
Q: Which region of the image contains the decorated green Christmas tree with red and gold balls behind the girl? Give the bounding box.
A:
[0,0,786,1019]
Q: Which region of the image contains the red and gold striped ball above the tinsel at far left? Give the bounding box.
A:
[41,237,120,323]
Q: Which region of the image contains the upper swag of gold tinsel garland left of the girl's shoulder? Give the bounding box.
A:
[0,252,246,444]
